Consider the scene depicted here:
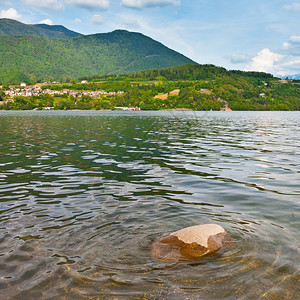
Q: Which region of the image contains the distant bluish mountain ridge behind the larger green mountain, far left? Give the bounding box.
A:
[0,19,81,38]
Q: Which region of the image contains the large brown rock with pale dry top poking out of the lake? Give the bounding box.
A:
[151,224,228,261]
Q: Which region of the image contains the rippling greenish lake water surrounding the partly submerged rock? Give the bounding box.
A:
[0,111,300,299]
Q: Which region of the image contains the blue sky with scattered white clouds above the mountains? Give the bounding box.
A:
[0,0,300,76]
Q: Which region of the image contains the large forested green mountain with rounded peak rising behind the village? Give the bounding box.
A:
[0,21,195,84]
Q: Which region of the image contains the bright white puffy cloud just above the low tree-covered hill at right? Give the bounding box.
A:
[246,48,283,73]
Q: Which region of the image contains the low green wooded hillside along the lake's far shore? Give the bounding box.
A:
[0,65,300,110]
